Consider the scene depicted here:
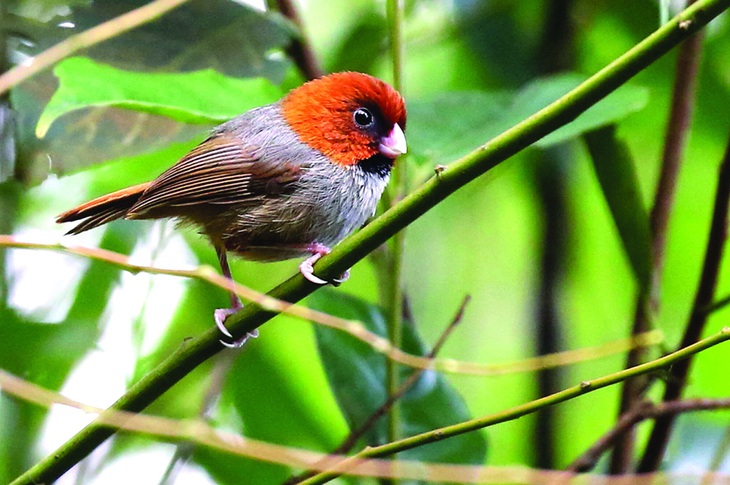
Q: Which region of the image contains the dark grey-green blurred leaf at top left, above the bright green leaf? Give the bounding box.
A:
[41,0,293,75]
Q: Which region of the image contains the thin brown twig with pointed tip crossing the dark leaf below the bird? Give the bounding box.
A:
[282,295,471,485]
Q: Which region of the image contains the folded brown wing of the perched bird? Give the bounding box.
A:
[126,130,301,219]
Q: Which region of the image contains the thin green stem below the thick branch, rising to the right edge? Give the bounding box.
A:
[300,327,730,485]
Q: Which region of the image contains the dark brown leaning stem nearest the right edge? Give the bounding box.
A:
[638,130,730,473]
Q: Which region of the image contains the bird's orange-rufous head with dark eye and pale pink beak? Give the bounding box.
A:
[281,72,406,166]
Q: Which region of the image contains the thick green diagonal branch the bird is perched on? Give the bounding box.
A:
[14,0,730,485]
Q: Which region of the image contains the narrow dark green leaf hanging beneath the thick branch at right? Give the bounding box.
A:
[584,125,651,290]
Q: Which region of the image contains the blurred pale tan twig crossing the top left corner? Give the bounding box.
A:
[0,0,188,94]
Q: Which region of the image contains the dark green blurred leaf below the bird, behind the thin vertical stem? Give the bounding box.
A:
[310,289,487,464]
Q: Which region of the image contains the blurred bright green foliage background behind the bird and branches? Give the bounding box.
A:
[0,0,730,483]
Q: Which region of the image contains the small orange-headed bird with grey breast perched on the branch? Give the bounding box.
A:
[56,72,406,347]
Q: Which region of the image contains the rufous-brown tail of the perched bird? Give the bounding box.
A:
[56,182,150,234]
